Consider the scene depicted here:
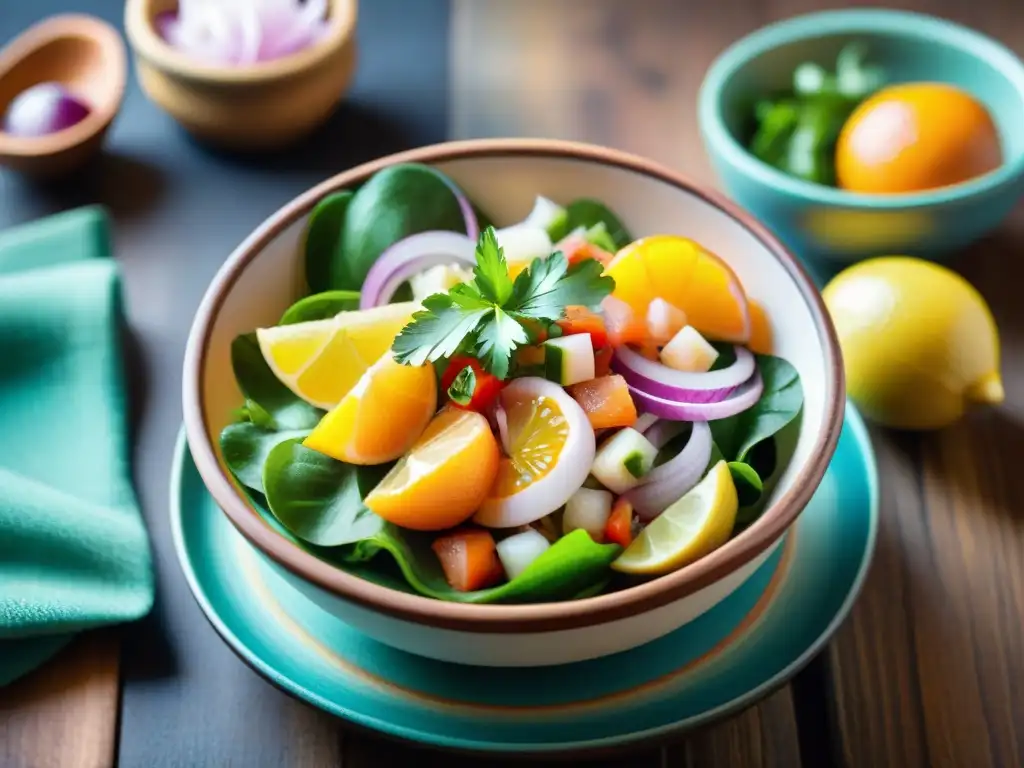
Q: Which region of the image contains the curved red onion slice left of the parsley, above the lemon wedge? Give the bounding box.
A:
[359,229,476,309]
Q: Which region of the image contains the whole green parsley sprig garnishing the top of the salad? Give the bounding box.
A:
[392,227,615,379]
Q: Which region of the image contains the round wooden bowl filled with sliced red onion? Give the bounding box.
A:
[125,0,357,152]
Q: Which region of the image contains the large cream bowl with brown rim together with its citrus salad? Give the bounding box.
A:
[185,141,843,666]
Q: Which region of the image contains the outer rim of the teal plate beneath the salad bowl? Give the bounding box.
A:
[170,403,879,755]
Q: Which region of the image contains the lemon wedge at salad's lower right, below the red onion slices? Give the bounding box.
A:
[611,461,739,575]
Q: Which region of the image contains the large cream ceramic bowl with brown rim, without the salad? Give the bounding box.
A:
[183,139,845,666]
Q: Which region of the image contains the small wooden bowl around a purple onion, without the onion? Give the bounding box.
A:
[0,14,128,178]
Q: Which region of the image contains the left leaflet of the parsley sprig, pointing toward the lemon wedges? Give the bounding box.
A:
[391,294,487,366]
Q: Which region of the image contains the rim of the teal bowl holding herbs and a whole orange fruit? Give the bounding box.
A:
[697,8,1024,211]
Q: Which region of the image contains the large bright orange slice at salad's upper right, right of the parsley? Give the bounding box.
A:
[605,234,751,343]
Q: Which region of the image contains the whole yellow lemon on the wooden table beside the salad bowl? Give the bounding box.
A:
[822,256,1004,429]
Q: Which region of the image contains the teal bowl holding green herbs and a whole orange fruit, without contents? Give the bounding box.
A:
[698,8,1024,266]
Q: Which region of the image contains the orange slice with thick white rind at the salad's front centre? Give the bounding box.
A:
[473,377,595,528]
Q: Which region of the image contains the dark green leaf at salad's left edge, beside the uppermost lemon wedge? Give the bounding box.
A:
[231,334,324,429]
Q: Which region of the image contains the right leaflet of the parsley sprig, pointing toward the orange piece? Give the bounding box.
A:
[507,252,615,323]
